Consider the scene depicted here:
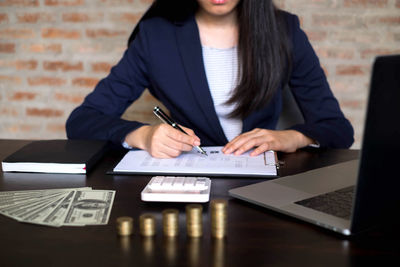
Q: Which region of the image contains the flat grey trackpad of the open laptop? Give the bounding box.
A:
[273,159,359,195]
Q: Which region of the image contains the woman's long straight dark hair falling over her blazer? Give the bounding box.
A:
[128,0,292,119]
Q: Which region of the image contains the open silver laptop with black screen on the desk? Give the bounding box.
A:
[229,55,400,235]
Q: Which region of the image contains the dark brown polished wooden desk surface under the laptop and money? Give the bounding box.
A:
[0,140,400,266]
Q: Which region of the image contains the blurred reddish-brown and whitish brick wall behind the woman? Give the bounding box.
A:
[0,0,400,147]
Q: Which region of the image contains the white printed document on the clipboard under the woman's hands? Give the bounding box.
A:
[113,146,277,176]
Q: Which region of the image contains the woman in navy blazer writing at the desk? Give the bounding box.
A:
[67,0,353,158]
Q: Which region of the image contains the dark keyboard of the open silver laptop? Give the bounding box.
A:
[295,186,354,219]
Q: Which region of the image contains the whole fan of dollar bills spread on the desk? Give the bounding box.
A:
[0,187,115,227]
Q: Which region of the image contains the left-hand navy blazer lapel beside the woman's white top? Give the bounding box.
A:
[176,16,228,144]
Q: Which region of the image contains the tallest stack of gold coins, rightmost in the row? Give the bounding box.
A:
[211,199,228,238]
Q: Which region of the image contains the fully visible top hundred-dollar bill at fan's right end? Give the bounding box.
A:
[63,190,115,226]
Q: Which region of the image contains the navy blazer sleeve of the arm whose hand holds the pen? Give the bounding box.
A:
[66,22,149,146]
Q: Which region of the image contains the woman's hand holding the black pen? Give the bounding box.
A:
[125,123,200,158]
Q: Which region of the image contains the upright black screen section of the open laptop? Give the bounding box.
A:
[352,55,400,232]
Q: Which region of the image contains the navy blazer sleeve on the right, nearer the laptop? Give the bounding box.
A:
[289,15,354,148]
